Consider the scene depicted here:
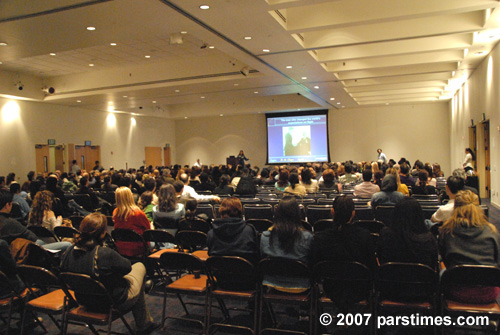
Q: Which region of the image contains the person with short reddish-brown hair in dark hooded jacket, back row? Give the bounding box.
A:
[207,198,259,264]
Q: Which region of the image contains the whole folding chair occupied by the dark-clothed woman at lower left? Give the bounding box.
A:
[59,272,135,335]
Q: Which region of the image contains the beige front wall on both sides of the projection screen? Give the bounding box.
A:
[175,103,451,174]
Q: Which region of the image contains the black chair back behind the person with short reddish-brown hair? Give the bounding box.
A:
[205,256,256,291]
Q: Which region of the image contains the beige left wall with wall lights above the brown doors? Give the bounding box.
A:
[0,98,175,181]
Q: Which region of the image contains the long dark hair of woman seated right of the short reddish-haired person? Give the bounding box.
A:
[269,196,302,252]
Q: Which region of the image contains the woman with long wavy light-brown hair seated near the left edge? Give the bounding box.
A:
[28,191,67,231]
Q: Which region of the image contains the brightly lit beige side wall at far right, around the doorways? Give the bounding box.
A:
[450,41,500,206]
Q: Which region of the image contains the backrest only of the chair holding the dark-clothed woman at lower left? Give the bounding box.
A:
[59,272,113,312]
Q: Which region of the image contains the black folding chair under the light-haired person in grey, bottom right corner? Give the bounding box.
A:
[441,265,500,334]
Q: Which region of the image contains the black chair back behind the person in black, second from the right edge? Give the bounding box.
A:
[375,262,439,301]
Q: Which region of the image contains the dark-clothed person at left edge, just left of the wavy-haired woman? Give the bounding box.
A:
[0,190,71,251]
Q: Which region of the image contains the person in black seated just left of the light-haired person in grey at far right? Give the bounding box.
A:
[377,197,438,269]
